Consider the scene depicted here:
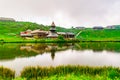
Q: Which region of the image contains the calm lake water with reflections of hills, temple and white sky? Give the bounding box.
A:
[0,42,120,75]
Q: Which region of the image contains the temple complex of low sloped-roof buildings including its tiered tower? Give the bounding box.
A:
[20,22,75,38]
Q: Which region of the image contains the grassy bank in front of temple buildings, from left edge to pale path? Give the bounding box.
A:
[0,38,79,43]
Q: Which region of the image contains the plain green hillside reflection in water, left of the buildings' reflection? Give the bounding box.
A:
[0,44,40,60]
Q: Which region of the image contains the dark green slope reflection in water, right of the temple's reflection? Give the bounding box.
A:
[75,42,120,52]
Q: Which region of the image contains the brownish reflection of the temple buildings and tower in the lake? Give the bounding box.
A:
[20,43,73,60]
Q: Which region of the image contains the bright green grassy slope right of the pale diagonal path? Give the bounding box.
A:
[76,29,120,41]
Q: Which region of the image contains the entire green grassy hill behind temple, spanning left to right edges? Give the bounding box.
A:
[0,21,120,41]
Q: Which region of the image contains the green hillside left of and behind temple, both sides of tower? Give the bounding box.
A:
[0,21,74,40]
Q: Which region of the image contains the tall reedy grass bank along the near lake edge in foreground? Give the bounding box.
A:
[0,65,120,80]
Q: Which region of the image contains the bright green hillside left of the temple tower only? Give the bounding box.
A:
[0,21,47,40]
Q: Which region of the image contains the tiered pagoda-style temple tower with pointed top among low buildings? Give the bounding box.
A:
[47,22,58,38]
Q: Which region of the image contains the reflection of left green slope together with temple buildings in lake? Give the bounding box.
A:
[0,43,73,60]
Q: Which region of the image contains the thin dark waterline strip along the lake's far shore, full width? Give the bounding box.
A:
[0,40,120,43]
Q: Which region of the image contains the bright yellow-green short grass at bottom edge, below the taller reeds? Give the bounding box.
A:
[14,73,120,80]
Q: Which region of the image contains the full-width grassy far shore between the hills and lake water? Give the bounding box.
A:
[0,38,120,43]
